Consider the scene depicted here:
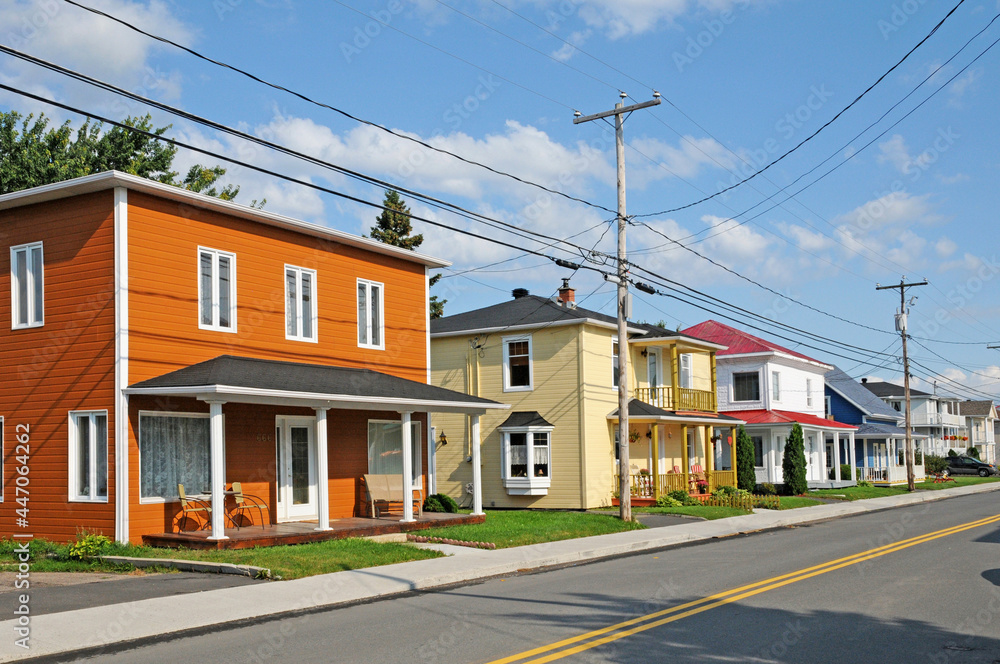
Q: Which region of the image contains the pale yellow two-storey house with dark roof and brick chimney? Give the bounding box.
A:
[431,280,740,509]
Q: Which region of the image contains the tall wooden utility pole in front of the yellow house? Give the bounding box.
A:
[573,91,661,521]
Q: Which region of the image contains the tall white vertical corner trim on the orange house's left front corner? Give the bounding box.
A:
[114,187,129,544]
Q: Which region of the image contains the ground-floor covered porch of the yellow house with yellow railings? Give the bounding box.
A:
[608,399,742,504]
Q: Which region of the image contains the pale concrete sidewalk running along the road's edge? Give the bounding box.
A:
[0,483,1000,662]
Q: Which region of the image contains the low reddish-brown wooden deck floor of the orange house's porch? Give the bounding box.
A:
[142,512,486,549]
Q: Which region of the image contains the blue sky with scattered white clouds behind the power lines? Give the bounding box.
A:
[0,0,1000,394]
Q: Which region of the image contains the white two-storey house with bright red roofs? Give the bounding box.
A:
[681,320,857,488]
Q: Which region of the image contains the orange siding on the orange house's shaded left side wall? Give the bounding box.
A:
[0,191,115,541]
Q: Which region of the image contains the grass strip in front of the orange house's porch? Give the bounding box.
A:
[0,539,442,579]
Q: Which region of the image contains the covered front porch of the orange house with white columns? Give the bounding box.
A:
[124,356,508,547]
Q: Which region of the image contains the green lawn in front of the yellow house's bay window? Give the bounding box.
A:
[418,510,645,549]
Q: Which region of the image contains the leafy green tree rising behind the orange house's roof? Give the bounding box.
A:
[0,111,242,205]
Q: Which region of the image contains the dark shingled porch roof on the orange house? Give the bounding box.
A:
[129,355,497,405]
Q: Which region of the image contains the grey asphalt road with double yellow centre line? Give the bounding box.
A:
[56,493,1000,664]
